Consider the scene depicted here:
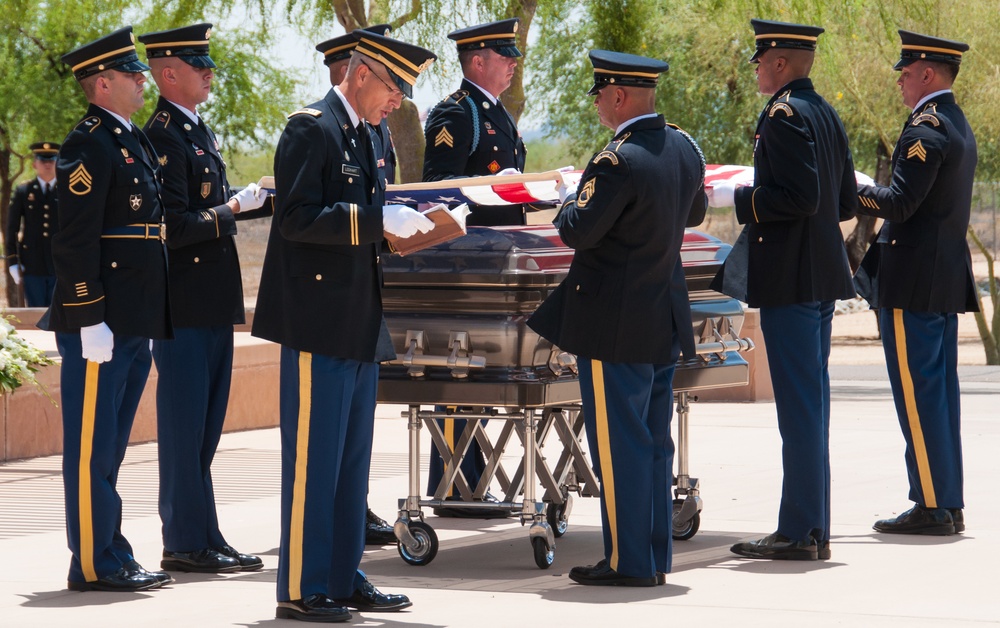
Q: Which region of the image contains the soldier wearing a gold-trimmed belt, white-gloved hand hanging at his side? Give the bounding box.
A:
[39,26,172,591]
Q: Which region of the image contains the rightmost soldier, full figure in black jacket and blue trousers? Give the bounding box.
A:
[856,30,979,534]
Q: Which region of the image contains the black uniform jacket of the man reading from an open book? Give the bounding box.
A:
[253,90,385,362]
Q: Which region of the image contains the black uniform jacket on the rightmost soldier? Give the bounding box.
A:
[856,92,979,313]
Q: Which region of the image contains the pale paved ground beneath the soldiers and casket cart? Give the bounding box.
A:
[0,366,1000,628]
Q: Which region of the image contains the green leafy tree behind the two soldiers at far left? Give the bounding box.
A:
[0,0,294,304]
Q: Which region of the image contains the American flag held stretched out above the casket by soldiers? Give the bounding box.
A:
[386,164,871,206]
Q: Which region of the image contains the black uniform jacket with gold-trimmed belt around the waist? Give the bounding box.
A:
[39,105,171,338]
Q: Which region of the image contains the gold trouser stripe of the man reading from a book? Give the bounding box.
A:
[288,351,312,600]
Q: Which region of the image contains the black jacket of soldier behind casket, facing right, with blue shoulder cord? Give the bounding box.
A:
[423,79,526,225]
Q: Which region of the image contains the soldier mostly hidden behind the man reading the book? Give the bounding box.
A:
[316,24,396,545]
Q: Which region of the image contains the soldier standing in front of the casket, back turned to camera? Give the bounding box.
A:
[528,50,706,586]
